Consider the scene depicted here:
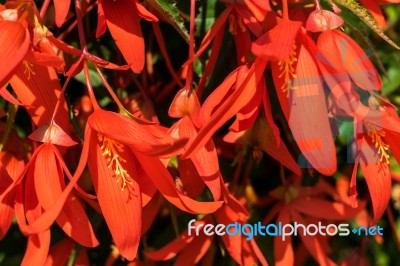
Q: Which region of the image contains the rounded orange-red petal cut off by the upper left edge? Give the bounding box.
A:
[0,20,29,88]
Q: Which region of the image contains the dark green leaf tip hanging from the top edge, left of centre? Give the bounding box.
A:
[147,0,189,43]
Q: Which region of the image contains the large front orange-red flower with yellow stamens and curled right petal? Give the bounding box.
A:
[83,110,222,260]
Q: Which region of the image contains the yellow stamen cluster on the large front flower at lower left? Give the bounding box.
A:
[97,134,133,191]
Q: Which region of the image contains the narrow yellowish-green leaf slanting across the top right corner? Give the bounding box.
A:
[335,0,400,50]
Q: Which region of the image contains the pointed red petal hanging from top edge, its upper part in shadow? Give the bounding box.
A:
[100,0,145,73]
